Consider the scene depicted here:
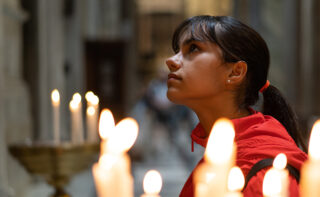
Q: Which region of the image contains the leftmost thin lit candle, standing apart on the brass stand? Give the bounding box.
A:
[51,89,60,144]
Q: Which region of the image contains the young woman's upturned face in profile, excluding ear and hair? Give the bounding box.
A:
[166,36,228,105]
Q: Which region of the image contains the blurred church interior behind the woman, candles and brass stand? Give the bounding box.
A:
[0,0,320,197]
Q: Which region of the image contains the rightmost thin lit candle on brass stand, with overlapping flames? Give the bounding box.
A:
[85,91,99,142]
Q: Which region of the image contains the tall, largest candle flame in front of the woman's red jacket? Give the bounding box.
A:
[205,118,235,164]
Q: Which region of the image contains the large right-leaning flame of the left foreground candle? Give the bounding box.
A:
[107,118,139,153]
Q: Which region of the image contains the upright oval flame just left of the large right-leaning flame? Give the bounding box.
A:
[99,109,115,140]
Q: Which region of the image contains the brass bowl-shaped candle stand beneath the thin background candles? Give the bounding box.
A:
[9,143,100,197]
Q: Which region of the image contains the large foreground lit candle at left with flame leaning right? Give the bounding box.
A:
[92,118,138,197]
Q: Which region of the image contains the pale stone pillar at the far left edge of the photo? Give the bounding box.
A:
[0,0,32,196]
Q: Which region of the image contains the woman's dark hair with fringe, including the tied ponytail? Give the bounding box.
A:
[172,15,306,151]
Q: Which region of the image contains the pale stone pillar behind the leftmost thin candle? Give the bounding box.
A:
[37,0,67,141]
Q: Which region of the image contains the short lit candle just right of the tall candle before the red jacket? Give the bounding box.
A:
[226,167,244,197]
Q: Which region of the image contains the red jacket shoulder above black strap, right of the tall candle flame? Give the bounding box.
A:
[235,112,307,174]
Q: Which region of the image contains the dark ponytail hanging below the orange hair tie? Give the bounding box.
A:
[262,85,307,152]
